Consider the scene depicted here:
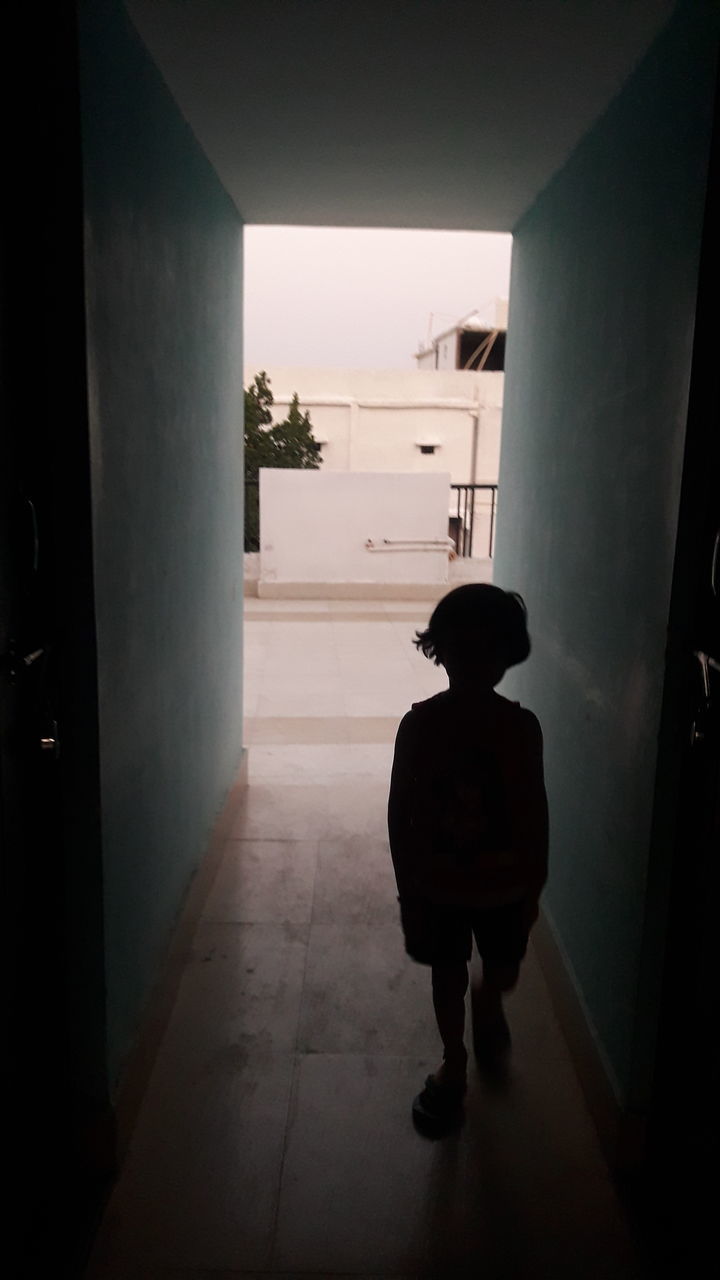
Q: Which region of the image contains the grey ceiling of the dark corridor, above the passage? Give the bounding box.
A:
[127,0,675,230]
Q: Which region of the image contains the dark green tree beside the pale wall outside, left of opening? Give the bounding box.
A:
[245,371,323,552]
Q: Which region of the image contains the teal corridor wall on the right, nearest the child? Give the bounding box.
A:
[495,3,717,1103]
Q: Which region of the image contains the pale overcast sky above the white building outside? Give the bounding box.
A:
[245,227,512,369]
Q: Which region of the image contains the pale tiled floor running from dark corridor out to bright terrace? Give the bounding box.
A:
[88,600,642,1280]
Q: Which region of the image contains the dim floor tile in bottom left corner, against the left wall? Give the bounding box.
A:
[87,1050,292,1280]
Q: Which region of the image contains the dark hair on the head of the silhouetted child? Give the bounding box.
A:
[414,582,530,668]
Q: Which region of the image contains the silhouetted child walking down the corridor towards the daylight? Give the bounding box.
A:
[388,584,547,1123]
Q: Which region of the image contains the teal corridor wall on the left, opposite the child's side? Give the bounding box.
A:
[79,0,242,1079]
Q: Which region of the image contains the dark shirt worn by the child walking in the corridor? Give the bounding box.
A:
[388,690,547,909]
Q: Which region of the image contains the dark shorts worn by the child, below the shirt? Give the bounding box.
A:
[400,899,529,968]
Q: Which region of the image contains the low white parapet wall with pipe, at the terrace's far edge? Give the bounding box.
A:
[258,470,451,599]
